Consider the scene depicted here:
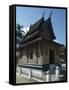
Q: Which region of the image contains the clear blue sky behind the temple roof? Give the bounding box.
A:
[16,6,66,45]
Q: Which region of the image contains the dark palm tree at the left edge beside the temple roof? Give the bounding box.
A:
[16,24,25,47]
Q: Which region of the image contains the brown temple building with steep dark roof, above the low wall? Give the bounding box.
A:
[18,15,63,65]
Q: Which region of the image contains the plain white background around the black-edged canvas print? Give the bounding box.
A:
[0,0,69,90]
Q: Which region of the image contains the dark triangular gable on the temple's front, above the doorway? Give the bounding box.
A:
[41,18,56,40]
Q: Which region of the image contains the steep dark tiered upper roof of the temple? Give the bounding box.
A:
[21,16,56,44]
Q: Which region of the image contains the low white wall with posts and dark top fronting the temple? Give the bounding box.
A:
[17,65,66,82]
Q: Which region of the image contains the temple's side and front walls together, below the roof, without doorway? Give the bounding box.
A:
[19,41,60,64]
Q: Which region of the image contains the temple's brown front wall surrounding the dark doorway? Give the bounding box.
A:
[42,42,60,64]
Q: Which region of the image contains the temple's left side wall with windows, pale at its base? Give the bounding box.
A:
[19,44,42,64]
